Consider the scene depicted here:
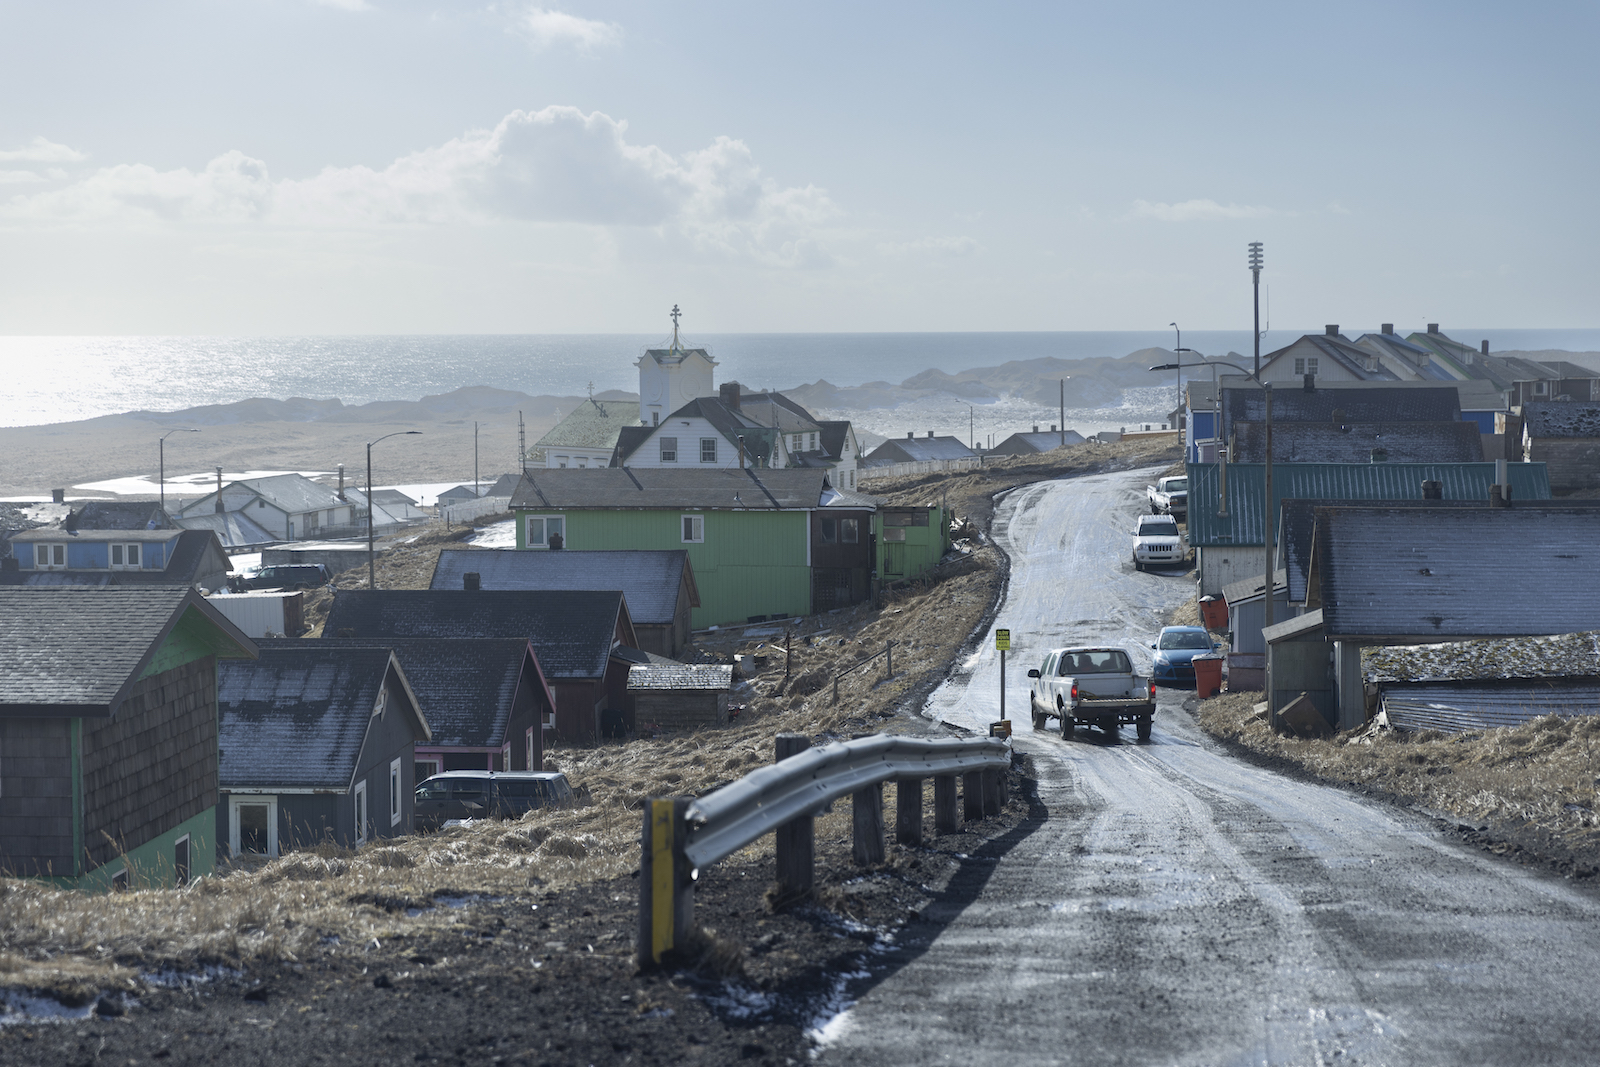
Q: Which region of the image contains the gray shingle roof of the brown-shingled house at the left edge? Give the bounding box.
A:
[0,585,256,717]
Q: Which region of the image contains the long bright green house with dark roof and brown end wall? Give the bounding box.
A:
[510,467,877,629]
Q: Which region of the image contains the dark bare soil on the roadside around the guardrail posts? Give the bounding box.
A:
[0,760,1038,1067]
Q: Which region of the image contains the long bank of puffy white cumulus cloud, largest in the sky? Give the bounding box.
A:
[0,106,837,266]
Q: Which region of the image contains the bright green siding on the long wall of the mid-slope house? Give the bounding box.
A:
[517,509,811,630]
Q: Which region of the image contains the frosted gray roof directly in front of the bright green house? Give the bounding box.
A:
[429,549,699,625]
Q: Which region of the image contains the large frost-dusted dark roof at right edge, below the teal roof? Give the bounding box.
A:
[1309,508,1600,640]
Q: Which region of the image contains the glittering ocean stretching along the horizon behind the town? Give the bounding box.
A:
[0,326,1600,426]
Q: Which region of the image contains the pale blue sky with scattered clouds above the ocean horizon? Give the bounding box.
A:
[0,0,1600,336]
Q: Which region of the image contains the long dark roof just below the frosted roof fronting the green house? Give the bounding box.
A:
[323,588,632,681]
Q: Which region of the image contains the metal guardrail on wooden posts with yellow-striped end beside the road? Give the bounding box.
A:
[638,734,1011,966]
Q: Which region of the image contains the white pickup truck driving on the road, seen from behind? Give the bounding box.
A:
[1027,648,1155,741]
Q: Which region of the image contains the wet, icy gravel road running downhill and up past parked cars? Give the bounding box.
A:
[819,470,1600,1067]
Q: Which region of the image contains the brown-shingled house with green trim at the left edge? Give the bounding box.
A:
[0,585,258,889]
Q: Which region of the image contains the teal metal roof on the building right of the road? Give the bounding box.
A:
[1189,462,1550,547]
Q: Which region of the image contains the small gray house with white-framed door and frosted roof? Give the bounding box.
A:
[216,640,432,857]
